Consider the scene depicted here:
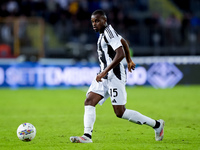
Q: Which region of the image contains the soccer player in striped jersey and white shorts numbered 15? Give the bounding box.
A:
[70,10,164,143]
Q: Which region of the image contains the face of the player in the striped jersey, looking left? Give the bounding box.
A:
[91,14,107,33]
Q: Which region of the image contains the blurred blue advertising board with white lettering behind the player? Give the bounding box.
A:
[0,57,200,88]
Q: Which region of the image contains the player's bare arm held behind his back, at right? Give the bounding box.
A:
[121,38,135,72]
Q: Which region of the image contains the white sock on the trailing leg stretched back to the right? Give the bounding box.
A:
[122,109,156,127]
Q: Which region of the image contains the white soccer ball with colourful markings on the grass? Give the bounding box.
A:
[17,123,36,142]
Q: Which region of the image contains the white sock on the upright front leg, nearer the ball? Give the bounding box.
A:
[84,105,96,135]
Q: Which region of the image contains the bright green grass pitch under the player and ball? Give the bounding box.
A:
[0,86,200,150]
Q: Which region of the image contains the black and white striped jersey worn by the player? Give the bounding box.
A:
[97,25,126,82]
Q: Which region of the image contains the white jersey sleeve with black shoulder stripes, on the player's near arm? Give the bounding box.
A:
[104,26,122,50]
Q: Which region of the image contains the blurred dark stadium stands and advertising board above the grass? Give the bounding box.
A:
[0,0,200,88]
